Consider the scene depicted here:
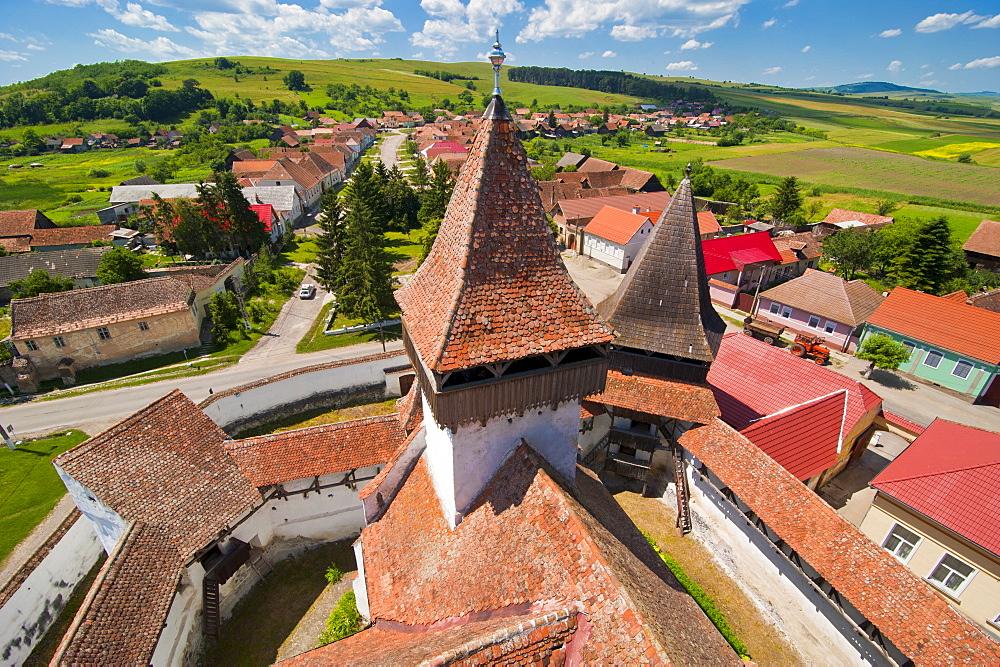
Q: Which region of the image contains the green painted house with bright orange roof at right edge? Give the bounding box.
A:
[861,287,1000,406]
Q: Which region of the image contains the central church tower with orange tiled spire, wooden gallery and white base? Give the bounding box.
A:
[396,37,613,526]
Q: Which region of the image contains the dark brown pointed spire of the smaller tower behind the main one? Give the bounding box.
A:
[600,177,726,363]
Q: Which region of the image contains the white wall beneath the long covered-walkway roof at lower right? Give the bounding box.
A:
[688,455,890,665]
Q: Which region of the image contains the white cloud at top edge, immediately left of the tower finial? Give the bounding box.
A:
[414,0,524,58]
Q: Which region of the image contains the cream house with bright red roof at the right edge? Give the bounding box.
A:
[861,418,1000,637]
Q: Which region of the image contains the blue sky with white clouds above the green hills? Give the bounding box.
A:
[0,0,1000,92]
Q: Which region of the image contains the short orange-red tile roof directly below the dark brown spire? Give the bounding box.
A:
[587,371,719,424]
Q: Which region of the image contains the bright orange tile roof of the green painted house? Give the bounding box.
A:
[868,287,1000,364]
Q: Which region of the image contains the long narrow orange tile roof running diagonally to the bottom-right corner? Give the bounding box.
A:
[680,421,1000,665]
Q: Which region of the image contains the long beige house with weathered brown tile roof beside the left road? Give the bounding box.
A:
[6,278,204,386]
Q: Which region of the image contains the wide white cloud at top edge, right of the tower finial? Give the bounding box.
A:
[517,0,750,43]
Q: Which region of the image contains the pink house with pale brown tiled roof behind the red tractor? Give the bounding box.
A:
[754,269,885,352]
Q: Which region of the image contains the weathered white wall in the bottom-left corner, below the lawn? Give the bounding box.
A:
[0,517,102,665]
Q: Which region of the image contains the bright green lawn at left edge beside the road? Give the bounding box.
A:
[0,430,90,562]
